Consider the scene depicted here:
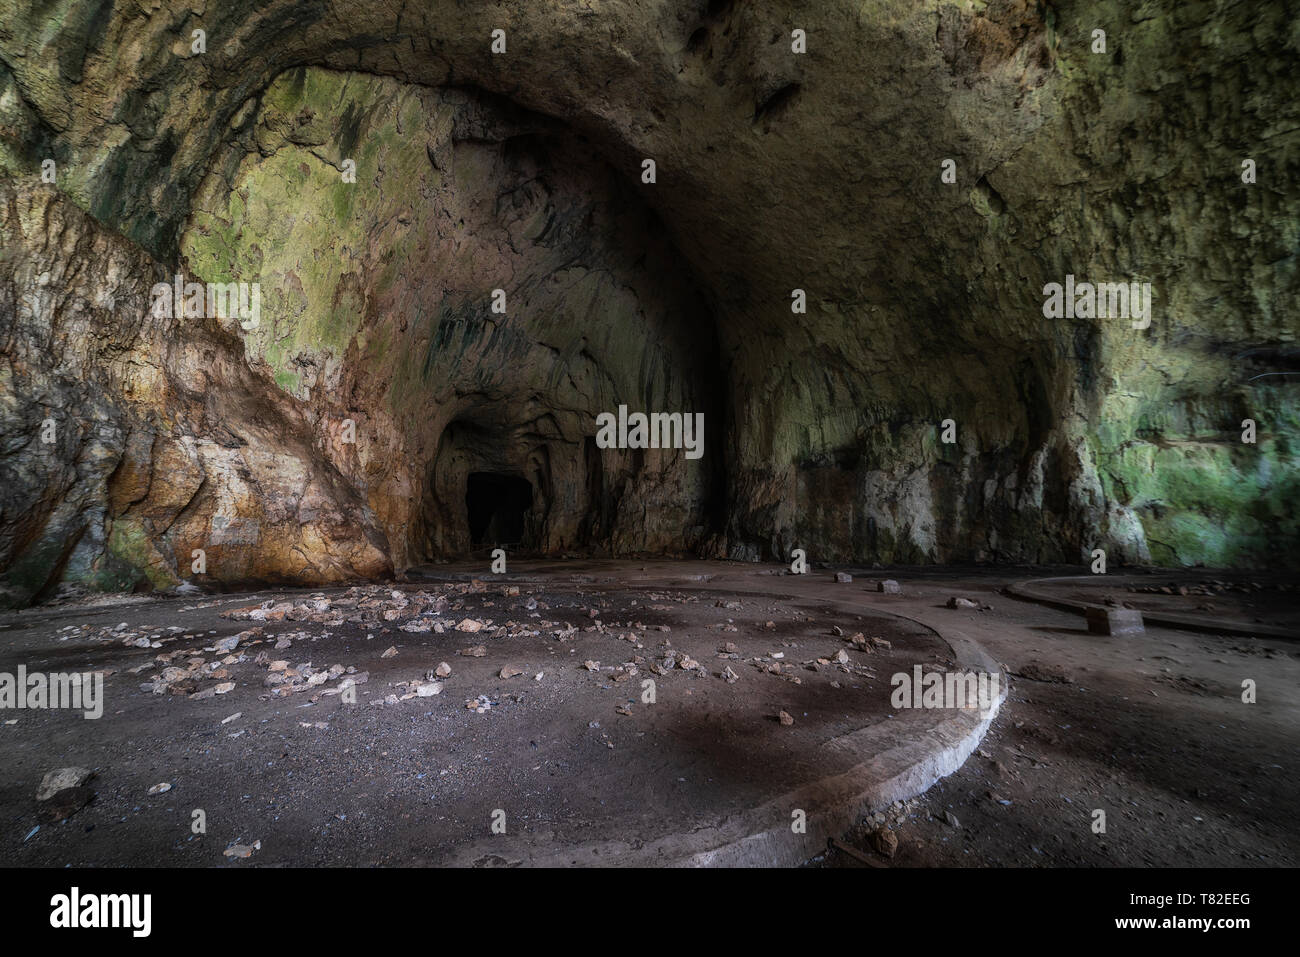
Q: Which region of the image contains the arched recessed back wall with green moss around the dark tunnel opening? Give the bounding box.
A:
[181,70,722,567]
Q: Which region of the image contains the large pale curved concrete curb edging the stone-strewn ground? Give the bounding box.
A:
[439,600,1008,867]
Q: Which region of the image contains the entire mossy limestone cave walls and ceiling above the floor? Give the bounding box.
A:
[0,0,1300,601]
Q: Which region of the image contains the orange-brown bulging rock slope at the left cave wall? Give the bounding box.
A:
[0,182,391,603]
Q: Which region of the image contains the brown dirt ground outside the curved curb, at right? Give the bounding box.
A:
[815,570,1300,867]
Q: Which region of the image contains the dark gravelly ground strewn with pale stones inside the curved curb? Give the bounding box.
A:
[0,581,948,866]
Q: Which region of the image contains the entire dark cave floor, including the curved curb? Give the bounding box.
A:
[0,562,1300,866]
